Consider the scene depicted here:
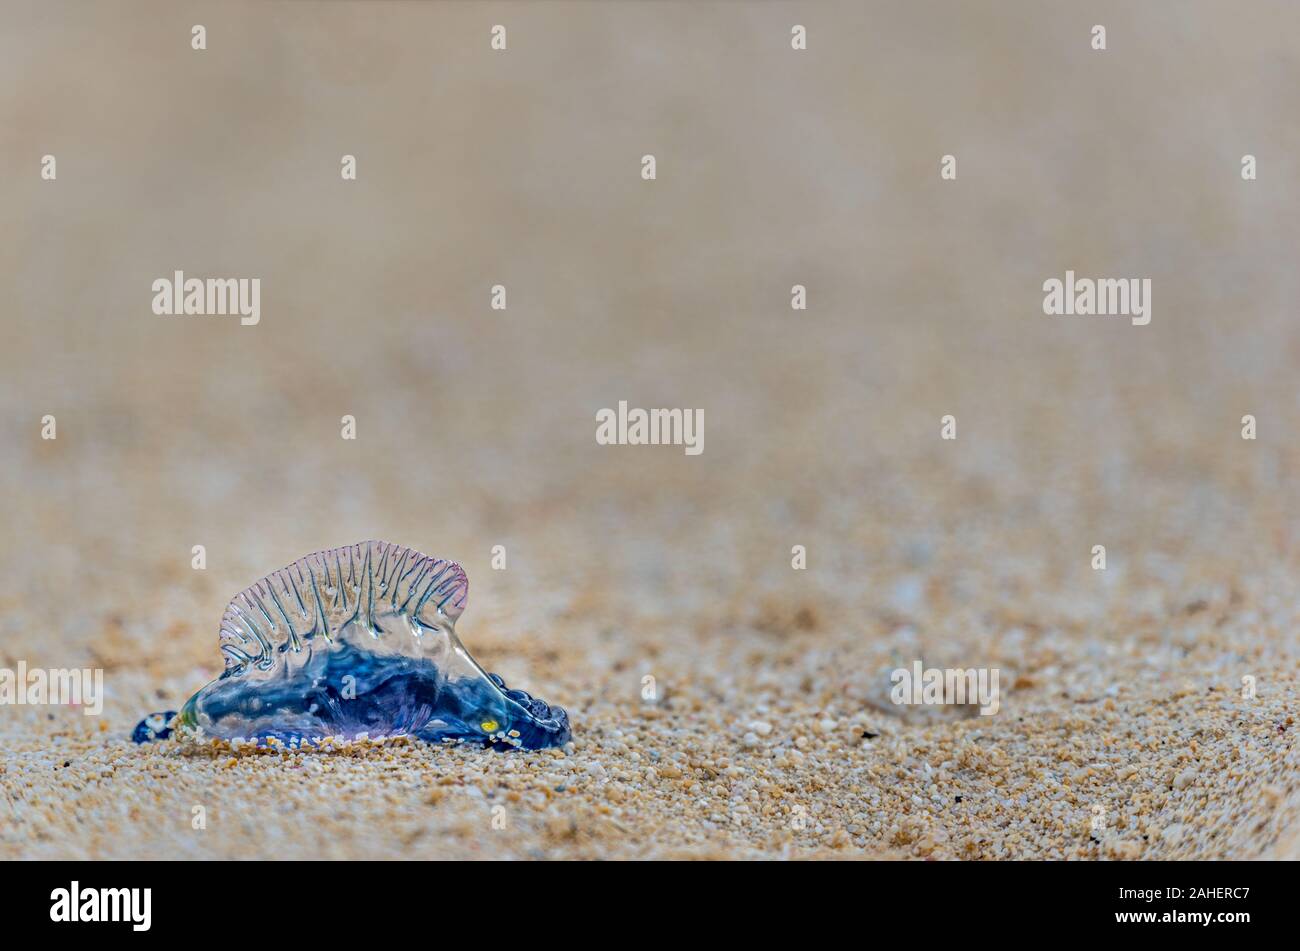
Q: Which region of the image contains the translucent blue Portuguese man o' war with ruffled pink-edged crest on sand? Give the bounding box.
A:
[133,542,571,750]
